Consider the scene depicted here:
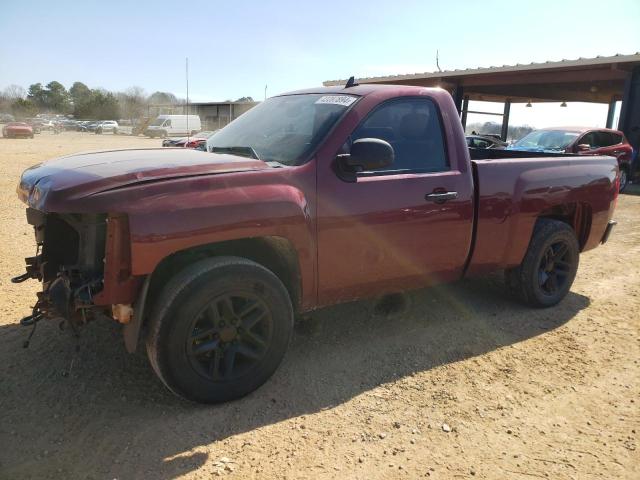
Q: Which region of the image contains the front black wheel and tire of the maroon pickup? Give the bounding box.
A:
[146,257,293,403]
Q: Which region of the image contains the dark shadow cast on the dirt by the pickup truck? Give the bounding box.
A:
[0,276,589,479]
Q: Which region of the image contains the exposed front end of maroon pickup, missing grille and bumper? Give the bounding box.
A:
[12,208,139,346]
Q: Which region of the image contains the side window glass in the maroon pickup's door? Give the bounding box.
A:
[351,98,449,174]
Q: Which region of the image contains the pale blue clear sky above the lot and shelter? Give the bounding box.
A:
[0,0,640,126]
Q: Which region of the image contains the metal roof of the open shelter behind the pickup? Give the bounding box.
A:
[323,52,640,103]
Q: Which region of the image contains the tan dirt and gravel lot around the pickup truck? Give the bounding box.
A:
[0,132,640,480]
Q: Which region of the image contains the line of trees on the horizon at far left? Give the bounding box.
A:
[0,81,184,120]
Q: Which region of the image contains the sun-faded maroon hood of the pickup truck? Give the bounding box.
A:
[17,148,270,211]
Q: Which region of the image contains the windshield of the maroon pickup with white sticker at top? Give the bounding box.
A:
[207,94,358,165]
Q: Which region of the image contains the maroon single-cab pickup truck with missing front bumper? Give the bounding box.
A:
[13,85,619,402]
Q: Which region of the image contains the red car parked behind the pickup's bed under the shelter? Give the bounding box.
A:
[507,127,633,192]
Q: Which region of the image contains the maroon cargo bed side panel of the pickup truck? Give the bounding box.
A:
[467,156,618,274]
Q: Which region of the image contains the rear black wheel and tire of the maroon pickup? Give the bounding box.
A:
[505,218,580,308]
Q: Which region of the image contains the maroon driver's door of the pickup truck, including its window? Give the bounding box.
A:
[318,97,473,304]
